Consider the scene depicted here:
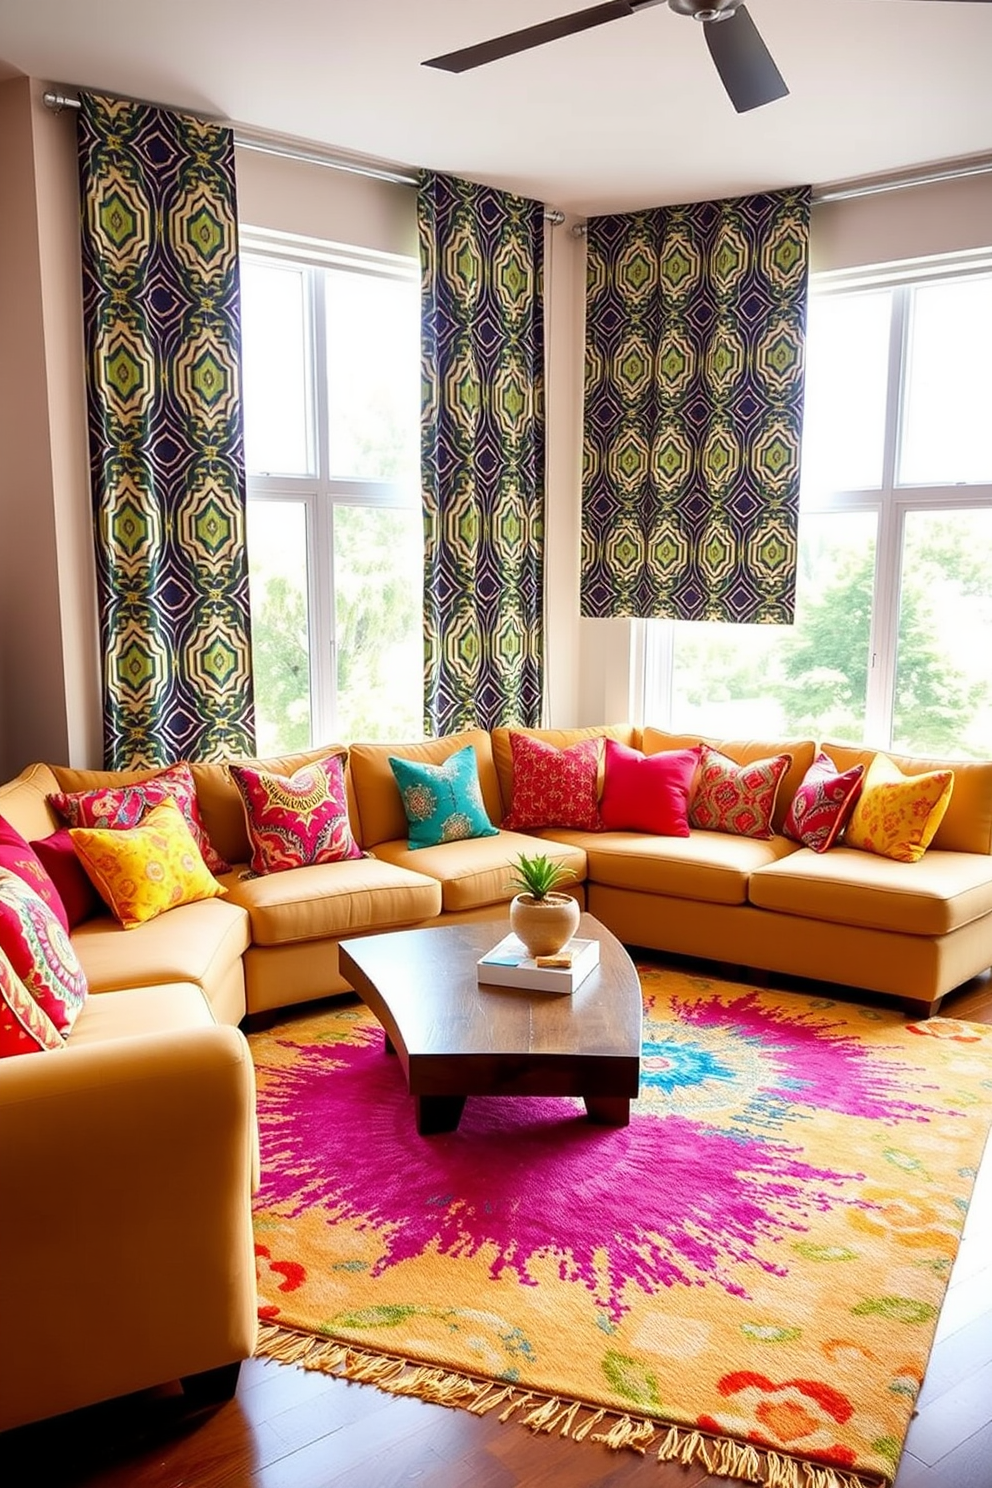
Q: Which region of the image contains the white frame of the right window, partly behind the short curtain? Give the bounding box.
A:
[631,248,992,748]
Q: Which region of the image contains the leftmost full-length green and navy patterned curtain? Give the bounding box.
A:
[79,94,254,768]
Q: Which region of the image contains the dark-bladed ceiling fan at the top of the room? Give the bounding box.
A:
[422,0,985,113]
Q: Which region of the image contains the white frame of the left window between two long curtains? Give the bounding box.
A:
[239,226,421,743]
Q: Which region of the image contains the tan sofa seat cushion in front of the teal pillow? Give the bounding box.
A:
[375,830,586,914]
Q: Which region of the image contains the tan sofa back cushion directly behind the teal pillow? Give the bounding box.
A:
[348,729,503,848]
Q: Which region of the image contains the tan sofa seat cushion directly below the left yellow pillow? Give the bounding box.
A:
[73,899,250,994]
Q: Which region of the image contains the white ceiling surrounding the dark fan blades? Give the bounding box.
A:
[0,0,992,216]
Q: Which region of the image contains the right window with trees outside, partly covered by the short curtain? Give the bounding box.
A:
[644,265,992,757]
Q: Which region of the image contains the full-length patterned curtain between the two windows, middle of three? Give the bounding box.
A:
[418,173,544,734]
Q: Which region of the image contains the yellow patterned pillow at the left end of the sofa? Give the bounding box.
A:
[70,801,228,930]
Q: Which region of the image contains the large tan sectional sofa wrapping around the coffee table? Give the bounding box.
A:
[0,725,992,1428]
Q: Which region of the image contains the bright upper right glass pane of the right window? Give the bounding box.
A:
[898,278,992,485]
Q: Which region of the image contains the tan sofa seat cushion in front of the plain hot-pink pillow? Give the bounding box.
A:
[549,827,799,905]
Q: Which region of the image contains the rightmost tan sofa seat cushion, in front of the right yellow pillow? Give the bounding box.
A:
[750,847,992,934]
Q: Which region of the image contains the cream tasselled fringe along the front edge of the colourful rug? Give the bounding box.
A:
[256,1323,891,1488]
